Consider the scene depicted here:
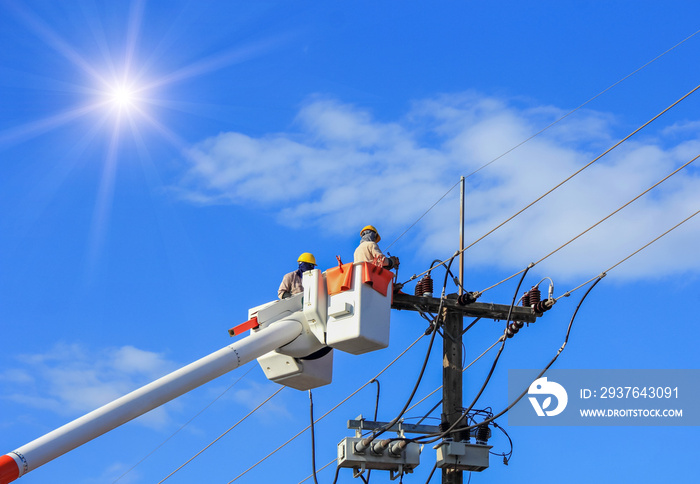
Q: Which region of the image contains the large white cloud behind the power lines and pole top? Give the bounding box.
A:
[179,93,700,278]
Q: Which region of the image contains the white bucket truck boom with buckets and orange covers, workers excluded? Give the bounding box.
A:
[0,263,393,484]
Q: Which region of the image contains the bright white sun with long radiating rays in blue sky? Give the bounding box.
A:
[0,0,289,279]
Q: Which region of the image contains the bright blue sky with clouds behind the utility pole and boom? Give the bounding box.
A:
[0,0,700,484]
